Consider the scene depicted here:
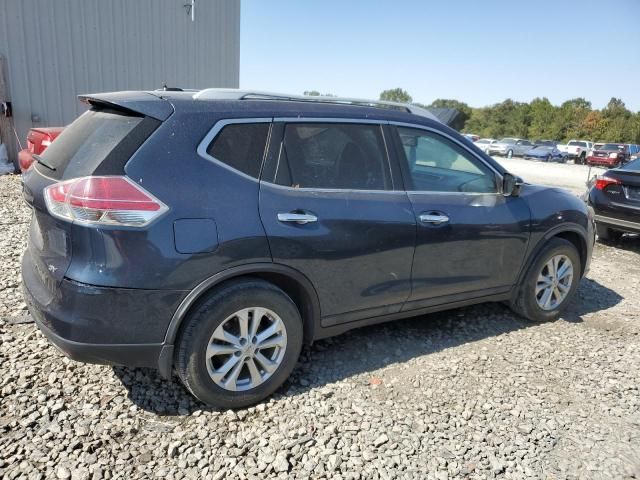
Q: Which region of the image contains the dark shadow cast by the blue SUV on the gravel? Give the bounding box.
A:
[113,279,622,416]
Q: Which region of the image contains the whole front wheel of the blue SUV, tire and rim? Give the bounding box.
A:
[511,238,581,322]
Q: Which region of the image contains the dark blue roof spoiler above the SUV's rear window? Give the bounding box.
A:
[78,91,173,122]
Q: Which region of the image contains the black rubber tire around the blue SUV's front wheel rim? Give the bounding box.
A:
[510,238,582,322]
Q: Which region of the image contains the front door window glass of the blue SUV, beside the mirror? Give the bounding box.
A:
[398,127,497,193]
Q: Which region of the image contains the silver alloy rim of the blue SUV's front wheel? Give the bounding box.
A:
[535,255,573,311]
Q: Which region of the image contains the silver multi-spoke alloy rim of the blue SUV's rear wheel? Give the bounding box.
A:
[206,307,287,392]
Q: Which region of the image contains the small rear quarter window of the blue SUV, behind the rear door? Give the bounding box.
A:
[207,123,269,178]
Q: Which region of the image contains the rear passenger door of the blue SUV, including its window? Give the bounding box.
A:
[260,119,416,326]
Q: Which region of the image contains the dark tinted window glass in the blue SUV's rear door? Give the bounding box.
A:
[276,123,391,190]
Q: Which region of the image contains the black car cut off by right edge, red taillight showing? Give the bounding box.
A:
[588,159,640,240]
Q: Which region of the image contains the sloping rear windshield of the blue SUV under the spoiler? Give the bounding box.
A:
[39,109,149,179]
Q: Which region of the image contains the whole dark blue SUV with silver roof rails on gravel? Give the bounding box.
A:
[22,89,594,407]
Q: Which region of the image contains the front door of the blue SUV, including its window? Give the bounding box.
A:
[394,126,531,309]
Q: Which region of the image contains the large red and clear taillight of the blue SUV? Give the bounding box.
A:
[44,176,167,227]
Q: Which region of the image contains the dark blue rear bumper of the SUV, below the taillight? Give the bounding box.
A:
[22,251,185,374]
